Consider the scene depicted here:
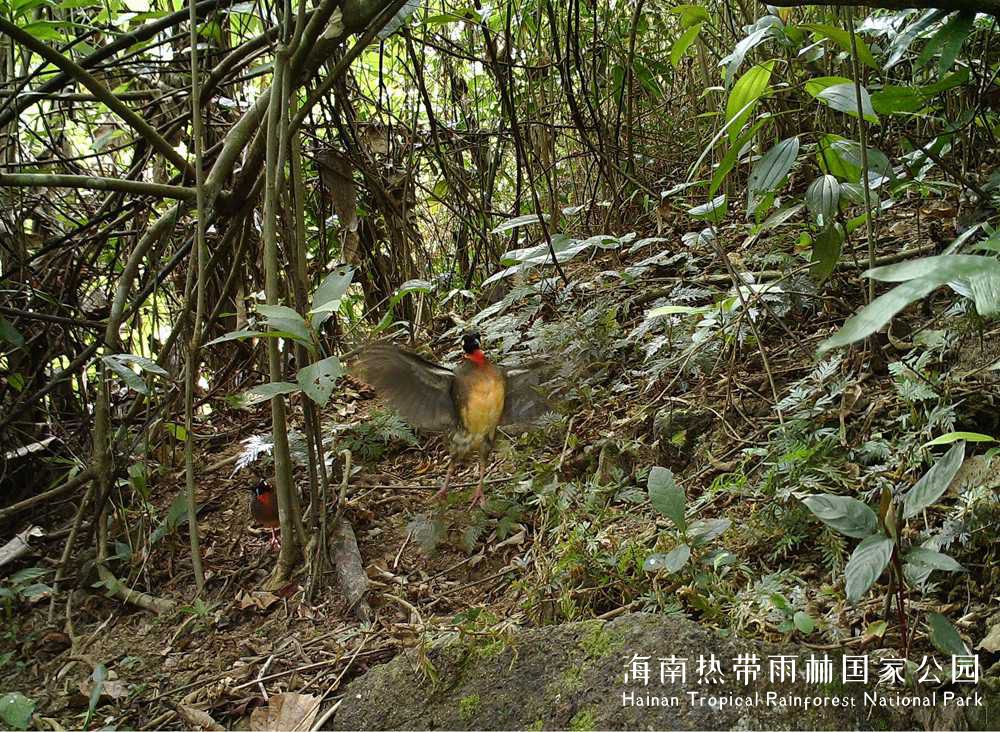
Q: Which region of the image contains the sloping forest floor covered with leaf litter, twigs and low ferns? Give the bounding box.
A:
[0,202,1000,729]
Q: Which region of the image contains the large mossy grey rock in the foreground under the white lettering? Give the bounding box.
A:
[330,614,1000,730]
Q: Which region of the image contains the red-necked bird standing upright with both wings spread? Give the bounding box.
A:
[355,333,549,506]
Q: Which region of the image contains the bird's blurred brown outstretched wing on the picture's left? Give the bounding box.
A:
[355,343,458,432]
